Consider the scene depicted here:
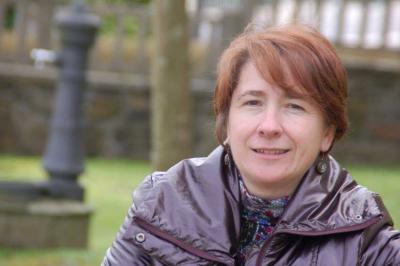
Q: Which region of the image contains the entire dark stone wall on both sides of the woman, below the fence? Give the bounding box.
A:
[0,67,400,163]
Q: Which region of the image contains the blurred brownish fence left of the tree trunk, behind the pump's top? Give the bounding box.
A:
[0,0,150,72]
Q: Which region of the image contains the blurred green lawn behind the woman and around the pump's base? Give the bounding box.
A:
[0,155,400,266]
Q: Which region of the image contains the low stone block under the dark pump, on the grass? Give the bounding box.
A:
[0,199,92,248]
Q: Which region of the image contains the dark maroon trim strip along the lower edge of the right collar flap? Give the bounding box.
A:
[256,215,383,266]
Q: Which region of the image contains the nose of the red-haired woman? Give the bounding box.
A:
[257,108,283,138]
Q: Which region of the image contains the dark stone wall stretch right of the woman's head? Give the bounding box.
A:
[335,67,400,164]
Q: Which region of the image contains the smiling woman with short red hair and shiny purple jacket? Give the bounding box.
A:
[103,25,400,265]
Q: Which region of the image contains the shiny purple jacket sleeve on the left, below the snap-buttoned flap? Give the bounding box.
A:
[101,208,156,266]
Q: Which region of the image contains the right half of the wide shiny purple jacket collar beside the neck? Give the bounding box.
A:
[275,156,385,235]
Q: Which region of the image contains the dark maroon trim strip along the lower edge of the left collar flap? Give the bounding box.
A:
[133,217,230,264]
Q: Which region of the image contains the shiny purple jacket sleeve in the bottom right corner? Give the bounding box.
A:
[360,225,400,266]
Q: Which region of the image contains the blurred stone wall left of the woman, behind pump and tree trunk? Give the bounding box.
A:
[0,68,219,160]
